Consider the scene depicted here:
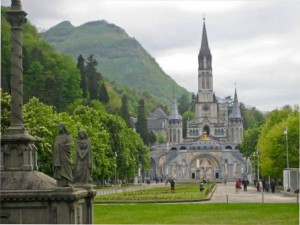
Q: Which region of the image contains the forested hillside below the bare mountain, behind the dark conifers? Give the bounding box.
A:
[1,7,164,116]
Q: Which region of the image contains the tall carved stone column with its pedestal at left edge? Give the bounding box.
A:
[0,0,36,171]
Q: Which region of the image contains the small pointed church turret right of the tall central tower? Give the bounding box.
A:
[228,88,244,144]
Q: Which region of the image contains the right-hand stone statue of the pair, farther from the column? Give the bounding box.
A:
[74,130,93,184]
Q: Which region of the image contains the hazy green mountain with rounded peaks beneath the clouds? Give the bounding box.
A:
[43,20,187,107]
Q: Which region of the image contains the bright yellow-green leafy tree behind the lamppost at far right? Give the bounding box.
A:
[258,108,299,178]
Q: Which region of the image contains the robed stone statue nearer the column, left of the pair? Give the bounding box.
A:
[53,123,73,187]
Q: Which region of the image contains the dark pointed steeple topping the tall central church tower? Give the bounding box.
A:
[198,18,212,70]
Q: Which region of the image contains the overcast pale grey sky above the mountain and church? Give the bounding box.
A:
[2,0,300,111]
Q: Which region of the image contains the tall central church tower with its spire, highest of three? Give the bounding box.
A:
[195,18,218,135]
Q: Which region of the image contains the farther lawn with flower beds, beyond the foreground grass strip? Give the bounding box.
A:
[95,184,212,203]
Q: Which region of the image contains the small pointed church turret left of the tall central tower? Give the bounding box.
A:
[168,95,183,144]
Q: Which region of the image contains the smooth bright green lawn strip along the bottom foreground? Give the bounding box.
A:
[94,203,299,225]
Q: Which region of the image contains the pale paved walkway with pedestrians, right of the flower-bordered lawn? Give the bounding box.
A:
[206,182,297,203]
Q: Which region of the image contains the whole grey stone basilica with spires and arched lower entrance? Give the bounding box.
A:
[145,20,249,180]
